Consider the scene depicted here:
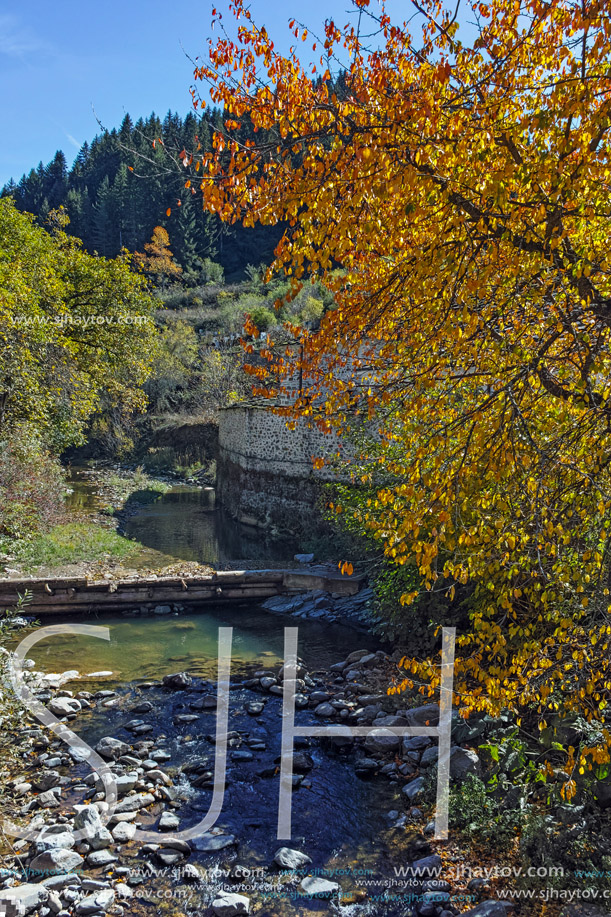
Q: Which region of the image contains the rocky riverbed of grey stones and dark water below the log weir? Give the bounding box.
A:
[0,596,506,917]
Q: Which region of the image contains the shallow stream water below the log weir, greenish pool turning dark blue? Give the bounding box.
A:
[16,607,424,917]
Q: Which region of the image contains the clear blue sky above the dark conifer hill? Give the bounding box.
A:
[0,0,440,186]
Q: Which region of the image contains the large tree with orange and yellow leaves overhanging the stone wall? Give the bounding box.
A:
[184,0,611,772]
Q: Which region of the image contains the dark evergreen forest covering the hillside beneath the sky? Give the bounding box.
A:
[2,109,280,285]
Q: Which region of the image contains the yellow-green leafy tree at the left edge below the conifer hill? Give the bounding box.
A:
[0,198,157,454]
